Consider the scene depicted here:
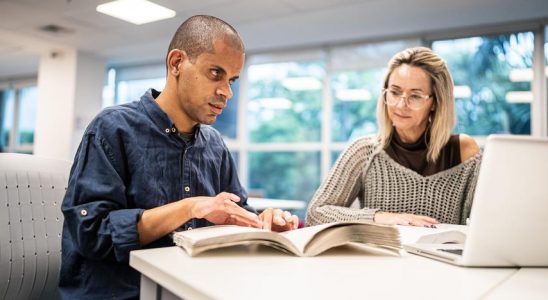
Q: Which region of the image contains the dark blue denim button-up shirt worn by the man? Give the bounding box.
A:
[59,90,253,299]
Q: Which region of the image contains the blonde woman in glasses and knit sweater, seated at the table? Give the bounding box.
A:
[306,47,481,227]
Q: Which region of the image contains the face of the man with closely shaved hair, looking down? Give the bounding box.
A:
[177,39,245,125]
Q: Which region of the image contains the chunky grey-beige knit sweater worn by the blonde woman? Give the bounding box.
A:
[306,137,481,226]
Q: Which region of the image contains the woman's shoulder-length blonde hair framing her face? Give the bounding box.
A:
[377,47,456,162]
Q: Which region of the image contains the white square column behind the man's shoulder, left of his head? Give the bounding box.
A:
[34,48,105,160]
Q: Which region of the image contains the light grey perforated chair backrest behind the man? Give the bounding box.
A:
[0,153,71,299]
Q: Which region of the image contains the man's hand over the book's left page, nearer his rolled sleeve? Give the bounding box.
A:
[192,192,263,228]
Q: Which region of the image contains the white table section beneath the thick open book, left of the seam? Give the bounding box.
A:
[130,247,518,300]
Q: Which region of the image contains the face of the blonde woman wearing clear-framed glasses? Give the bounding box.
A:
[386,65,434,138]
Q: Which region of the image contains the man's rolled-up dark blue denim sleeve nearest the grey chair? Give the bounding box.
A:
[62,132,143,262]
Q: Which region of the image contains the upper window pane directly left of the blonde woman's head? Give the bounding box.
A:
[329,40,420,143]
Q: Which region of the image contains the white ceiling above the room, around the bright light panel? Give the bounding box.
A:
[0,0,548,80]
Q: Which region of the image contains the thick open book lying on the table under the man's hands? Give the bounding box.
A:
[173,221,401,256]
